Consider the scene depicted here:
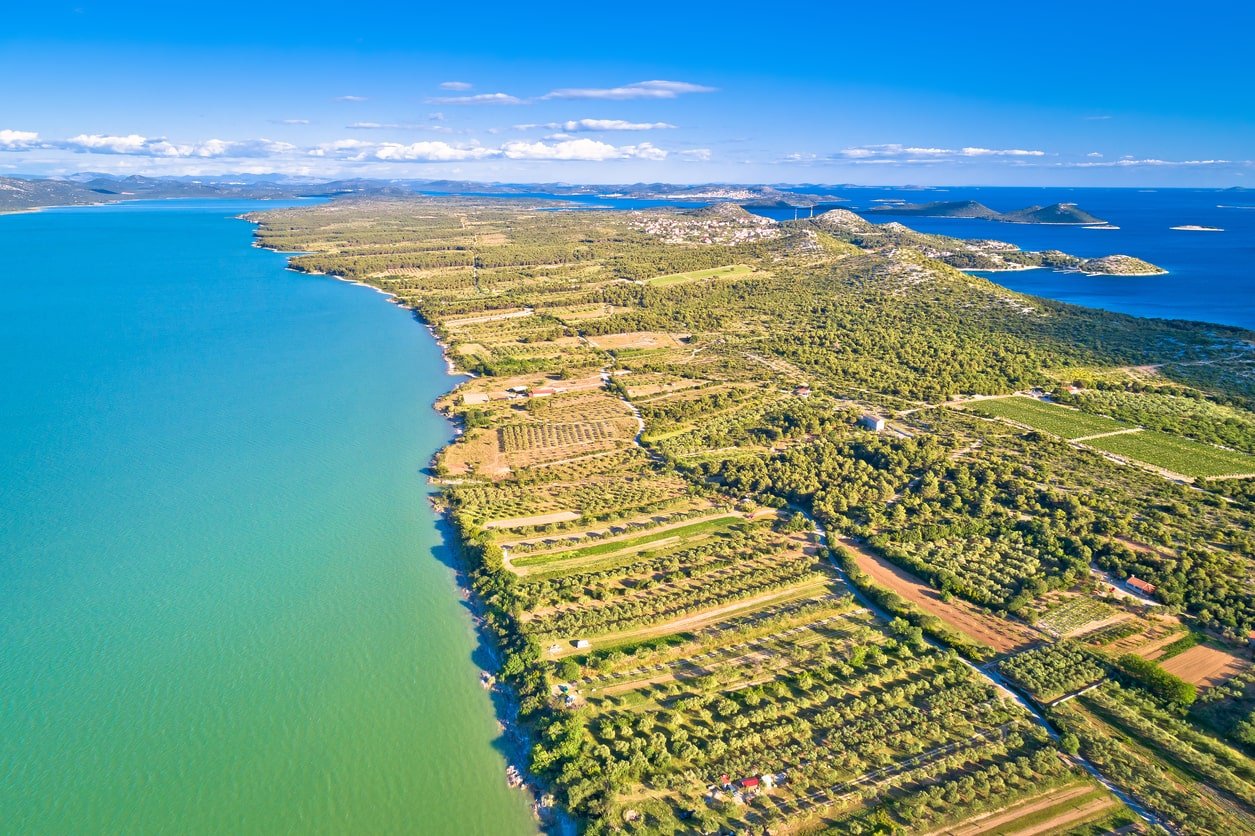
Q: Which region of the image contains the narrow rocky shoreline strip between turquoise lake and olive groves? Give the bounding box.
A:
[244,215,554,833]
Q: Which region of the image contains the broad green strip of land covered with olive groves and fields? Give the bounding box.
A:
[250,197,1255,833]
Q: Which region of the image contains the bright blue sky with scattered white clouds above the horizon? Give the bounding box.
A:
[0,0,1255,186]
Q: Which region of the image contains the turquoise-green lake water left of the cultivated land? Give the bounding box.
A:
[0,201,536,835]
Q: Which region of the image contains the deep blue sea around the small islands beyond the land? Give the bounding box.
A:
[434,186,1255,329]
